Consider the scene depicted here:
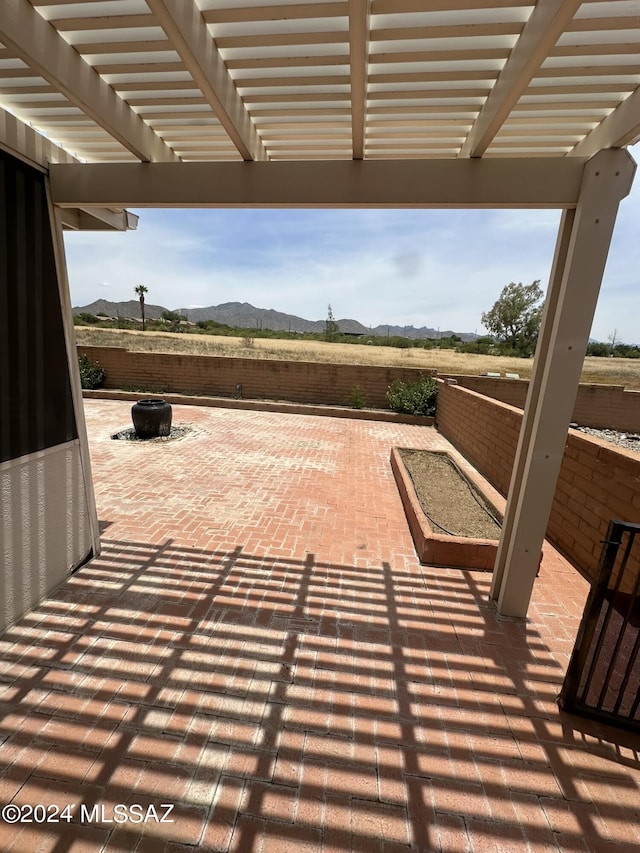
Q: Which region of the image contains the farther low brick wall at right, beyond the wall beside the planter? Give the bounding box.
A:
[442,374,640,432]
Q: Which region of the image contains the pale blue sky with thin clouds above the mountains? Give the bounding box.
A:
[65,145,640,343]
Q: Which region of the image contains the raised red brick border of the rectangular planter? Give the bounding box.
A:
[391,447,501,572]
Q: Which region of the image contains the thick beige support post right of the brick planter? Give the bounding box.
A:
[491,149,635,617]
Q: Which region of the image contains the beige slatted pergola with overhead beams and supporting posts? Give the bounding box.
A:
[0,0,640,616]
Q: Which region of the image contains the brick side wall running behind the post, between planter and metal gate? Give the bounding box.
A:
[437,383,640,580]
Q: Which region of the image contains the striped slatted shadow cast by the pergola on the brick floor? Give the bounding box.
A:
[0,540,640,853]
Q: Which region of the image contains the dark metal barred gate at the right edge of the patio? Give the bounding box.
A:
[558,521,640,731]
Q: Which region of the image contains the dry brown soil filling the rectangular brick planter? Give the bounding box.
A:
[399,449,500,539]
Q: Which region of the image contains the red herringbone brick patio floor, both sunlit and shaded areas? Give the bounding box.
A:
[0,401,640,853]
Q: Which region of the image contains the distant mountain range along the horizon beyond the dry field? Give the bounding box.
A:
[73,299,476,341]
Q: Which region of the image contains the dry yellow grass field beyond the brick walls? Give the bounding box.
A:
[76,326,640,390]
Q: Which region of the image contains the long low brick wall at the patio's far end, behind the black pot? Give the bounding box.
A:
[78,347,435,409]
